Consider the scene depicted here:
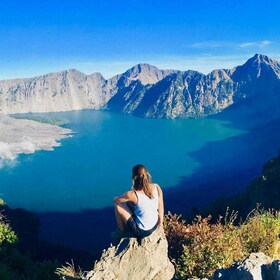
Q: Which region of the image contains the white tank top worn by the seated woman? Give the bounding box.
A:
[134,185,158,230]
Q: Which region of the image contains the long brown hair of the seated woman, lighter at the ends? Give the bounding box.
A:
[132,164,154,199]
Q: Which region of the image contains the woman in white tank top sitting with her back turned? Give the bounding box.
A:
[112,164,164,239]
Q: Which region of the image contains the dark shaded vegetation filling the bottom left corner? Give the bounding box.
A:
[0,201,94,280]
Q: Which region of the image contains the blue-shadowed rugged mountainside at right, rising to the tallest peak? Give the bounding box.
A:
[108,54,280,118]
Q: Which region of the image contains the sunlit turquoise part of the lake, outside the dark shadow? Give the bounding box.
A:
[0,111,244,212]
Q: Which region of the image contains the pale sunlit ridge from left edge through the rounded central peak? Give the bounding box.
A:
[0,64,174,114]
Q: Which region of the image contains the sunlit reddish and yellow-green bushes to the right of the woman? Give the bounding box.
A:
[164,209,280,279]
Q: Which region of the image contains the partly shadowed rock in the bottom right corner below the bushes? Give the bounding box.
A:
[211,252,280,280]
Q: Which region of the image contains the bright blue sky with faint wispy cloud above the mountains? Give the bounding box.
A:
[0,0,280,79]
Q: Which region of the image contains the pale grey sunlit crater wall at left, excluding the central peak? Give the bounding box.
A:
[0,70,109,114]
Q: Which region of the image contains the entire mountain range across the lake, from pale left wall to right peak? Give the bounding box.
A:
[0,54,280,118]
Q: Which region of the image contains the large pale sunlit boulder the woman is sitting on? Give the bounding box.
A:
[86,228,175,280]
